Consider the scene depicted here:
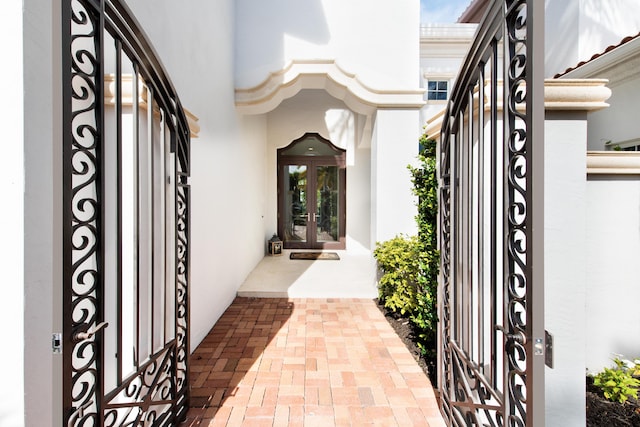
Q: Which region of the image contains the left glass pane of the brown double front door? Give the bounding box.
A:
[284,165,307,242]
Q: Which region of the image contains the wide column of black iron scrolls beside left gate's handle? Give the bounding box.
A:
[65,1,102,425]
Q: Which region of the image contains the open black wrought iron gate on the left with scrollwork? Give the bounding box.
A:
[62,0,190,426]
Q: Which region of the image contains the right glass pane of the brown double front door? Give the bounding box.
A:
[315,166,340,242]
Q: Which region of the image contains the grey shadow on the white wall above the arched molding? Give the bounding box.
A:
[235,0,331,87]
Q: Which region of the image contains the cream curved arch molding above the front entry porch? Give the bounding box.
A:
[235,60,424,116]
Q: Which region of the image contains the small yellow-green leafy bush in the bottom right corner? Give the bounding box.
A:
[593,357,640,403]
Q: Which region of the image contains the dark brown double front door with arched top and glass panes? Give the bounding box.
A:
[278,134,346,249]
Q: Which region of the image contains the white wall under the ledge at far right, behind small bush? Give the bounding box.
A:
[585,175,640,373]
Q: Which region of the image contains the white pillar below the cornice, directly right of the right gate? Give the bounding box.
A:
[544,112,591,427]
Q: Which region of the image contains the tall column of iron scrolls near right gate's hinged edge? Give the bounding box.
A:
[505,0,528,426]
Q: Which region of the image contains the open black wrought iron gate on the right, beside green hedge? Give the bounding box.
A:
[439,0,544,426]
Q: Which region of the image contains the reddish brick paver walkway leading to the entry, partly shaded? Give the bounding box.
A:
[182,298,444,427]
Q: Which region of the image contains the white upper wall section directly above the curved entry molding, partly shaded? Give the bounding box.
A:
[235,0,420,89]
